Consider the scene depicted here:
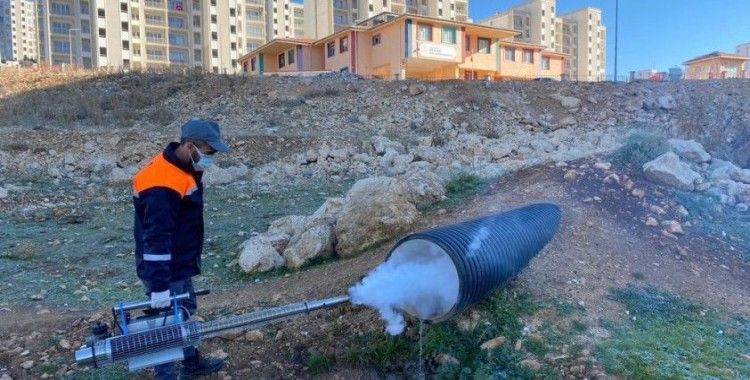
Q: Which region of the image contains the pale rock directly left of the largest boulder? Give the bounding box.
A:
[283,219,335,269]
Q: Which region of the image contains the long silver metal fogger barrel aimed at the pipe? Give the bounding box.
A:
[75,296,349,368]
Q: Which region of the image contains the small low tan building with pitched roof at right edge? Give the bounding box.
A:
[683,51,750,79]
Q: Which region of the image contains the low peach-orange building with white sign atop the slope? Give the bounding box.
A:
[240,13,566,80]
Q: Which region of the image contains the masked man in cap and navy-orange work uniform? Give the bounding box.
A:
[133,120,229,379]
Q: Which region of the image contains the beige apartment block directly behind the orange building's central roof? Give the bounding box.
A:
[304,0,469,38]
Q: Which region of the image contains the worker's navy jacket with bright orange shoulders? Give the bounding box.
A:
[133,143,203,292]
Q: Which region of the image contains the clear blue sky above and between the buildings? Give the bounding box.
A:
[469,0,750,77]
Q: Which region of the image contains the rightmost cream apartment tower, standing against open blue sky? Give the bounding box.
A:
[560,7,607,82]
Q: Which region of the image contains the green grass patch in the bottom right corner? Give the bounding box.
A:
[595,286,750,379]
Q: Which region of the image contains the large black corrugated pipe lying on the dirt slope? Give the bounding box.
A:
[388,203,561,322]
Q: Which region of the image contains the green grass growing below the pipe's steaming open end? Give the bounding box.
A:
[345,288,586,379]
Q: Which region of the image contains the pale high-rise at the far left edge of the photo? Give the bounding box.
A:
[0,0,39,61]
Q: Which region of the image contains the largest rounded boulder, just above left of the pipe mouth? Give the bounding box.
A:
[335,177,419,257]
